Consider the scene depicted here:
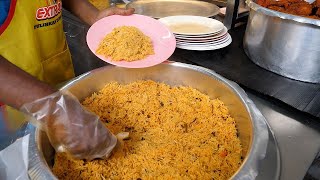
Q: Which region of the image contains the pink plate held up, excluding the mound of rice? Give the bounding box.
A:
[87,14,176,68]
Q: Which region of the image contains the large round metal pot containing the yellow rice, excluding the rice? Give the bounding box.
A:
[29,62,268,179]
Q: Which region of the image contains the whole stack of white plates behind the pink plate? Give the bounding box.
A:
[159,16,232,51]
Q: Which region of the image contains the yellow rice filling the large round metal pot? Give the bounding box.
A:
[53,81,242,180]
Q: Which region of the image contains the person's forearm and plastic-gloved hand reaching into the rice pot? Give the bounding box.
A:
[0,55,118,160]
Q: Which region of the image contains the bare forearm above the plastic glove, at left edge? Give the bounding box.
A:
[0,56,56,109]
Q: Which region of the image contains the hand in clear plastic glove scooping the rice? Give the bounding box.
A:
[20,91,118,160]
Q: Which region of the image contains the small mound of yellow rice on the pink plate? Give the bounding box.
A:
[96,26,154,61]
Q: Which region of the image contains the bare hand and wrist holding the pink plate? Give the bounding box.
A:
[63,0,134,25]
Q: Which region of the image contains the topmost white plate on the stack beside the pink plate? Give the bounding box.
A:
[159,16,224,36]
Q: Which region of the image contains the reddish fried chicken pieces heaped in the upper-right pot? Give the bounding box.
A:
[256,0,320,19]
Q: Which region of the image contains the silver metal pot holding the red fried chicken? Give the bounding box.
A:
[243,0,320,83]
